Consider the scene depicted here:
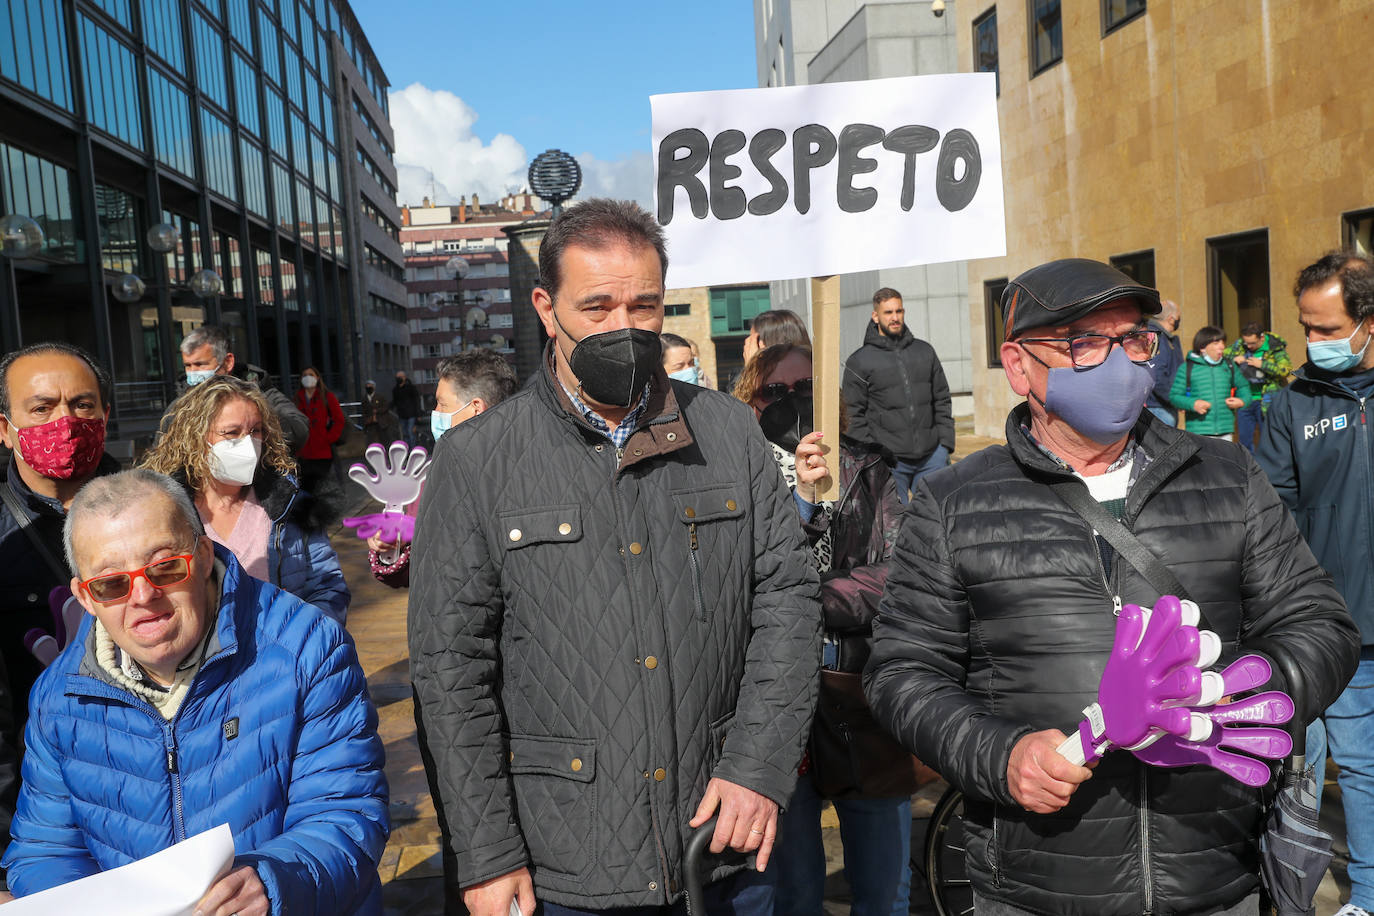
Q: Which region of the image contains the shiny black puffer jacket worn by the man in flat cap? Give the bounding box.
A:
[866,405,1359,916]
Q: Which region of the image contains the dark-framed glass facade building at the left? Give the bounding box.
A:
[0,0,408,438]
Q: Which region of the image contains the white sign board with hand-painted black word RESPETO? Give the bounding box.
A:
[650,73,1007,287]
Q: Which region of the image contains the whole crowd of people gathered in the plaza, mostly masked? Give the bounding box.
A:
[0,199,1374,916]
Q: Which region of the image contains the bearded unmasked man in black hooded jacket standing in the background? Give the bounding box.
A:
[844,287,954,503]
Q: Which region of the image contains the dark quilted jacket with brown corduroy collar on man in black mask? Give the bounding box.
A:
[409,359,820,909]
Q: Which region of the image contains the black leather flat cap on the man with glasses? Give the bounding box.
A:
[1002,258,1160,341]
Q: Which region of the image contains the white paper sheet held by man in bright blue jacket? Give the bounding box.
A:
[0,824,234,916]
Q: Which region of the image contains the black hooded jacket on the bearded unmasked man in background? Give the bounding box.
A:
[844,321,954,461]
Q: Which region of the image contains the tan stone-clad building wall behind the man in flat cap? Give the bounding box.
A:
[952,0,1374,435]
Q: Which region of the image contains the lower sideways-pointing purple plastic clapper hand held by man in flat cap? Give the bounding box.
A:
[1131,655,1294,787]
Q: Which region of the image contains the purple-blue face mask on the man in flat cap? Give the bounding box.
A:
[1044,346,1154,445]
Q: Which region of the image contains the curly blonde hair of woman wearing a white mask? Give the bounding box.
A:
[139,375,295,492]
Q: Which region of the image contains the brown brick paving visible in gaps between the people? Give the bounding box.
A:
[333,423,1349,916]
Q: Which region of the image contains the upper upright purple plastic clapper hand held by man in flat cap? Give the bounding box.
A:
[1059,595,1202,764]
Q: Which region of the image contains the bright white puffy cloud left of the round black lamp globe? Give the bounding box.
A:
[390,82,529,206]
